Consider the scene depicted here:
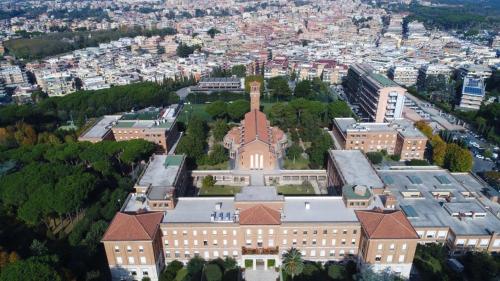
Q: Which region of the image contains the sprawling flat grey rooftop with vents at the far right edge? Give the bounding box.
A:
[379,169,500,235]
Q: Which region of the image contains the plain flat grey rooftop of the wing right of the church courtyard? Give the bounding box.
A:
[330,150,384,188]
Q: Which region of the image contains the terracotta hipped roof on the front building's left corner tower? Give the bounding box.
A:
[102,212,163,241]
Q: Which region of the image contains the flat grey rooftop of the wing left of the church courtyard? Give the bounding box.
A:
[137,154,184,187]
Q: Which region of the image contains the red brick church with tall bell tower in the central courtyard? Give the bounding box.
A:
[224,81,288,170]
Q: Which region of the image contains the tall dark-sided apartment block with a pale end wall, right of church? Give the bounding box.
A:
[346,64,406,123]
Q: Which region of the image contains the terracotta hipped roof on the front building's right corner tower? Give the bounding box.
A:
[356,210,418,239]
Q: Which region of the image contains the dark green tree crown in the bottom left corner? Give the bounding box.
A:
[0,260,61,281]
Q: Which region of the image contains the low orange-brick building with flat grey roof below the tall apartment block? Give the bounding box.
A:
[332,118,427,160]
